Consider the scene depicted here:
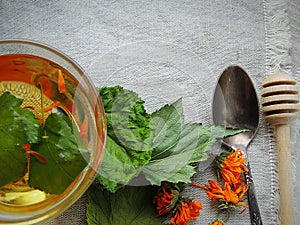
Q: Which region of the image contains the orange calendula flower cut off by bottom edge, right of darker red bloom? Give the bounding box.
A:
[170,199,202,225]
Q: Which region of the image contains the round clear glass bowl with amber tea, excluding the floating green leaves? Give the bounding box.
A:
[0,40,106,224]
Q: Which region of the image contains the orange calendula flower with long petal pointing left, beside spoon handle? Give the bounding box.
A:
[192,180,248,213]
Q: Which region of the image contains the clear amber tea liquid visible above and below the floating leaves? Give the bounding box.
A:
[0,54,84,207]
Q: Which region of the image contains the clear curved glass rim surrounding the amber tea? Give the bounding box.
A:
[0,39,106,224]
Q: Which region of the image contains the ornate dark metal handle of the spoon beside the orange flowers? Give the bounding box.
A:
[245,162,263,225]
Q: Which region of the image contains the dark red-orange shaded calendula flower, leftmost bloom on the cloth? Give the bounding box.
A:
[153,182,179,216]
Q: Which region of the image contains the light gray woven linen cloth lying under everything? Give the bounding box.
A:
[0,0,300,225]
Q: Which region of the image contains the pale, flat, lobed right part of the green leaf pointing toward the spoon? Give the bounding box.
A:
[143,100,231,185]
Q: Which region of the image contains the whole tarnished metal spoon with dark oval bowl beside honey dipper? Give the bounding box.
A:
[212,66,262,225]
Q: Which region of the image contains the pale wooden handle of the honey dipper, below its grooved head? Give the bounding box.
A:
[276,124,295,225]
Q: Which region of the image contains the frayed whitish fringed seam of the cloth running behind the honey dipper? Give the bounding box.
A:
[263,0,292,225]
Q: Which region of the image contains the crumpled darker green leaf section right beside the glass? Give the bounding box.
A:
[99,86,153,166]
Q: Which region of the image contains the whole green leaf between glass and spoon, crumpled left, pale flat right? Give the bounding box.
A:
[97,86,248,192]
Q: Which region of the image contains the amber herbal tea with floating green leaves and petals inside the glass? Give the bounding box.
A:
[0,54,93,206]
